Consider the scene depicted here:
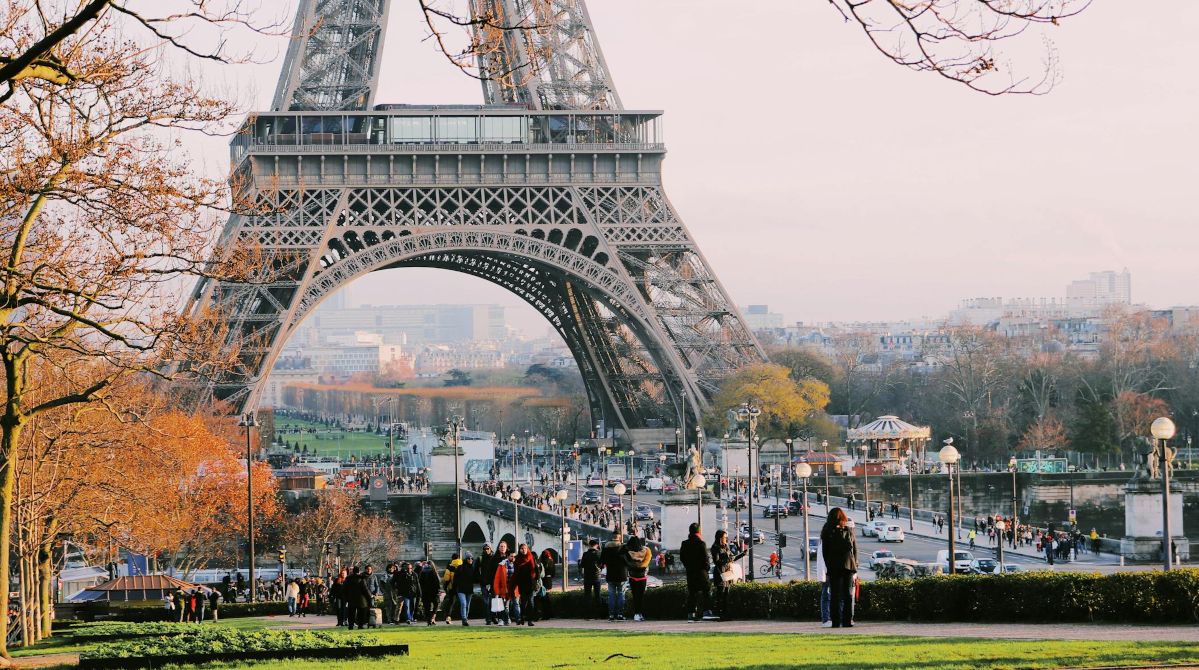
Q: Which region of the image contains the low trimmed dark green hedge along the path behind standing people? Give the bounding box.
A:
[550,569,1199,623]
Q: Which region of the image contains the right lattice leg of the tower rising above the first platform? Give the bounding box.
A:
[471,0,622,109]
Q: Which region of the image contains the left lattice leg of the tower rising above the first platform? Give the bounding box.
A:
[271,0,391,111]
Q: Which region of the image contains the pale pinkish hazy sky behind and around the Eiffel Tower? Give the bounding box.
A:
[187,0,1199,328]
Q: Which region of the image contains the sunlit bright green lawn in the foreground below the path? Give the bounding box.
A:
[16,618,1199,670]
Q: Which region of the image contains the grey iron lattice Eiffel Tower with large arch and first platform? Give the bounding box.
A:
[189,0,764,442]
